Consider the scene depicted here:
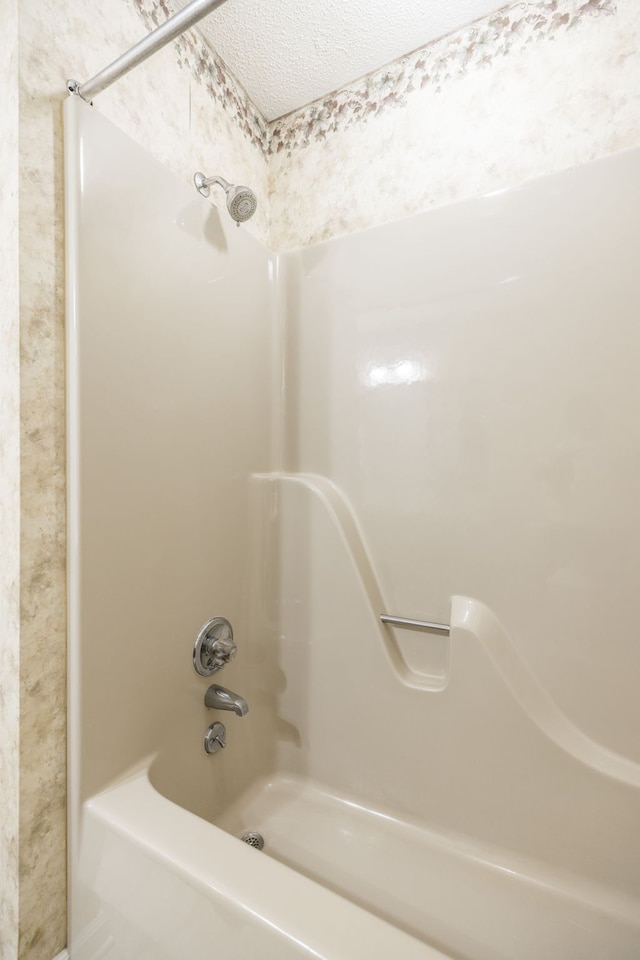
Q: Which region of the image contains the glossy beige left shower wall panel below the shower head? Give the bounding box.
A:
[65,98,272,836]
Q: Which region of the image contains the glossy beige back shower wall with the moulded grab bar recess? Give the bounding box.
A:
[281,151,640,886]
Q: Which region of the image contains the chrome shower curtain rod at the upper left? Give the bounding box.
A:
[67,0,225,103]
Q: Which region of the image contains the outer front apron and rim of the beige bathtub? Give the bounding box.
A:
[72,770,441,960]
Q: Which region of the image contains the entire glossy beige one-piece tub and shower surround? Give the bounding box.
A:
[66,101,640,960]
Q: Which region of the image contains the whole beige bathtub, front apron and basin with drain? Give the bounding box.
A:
[71,769,640,960]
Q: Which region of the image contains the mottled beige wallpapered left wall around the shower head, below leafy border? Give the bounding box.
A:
[14,0,267,960]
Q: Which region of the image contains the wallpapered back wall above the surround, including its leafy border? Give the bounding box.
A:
[270,0,640,249]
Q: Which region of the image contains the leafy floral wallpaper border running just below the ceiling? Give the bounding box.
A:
[134,0,617,156]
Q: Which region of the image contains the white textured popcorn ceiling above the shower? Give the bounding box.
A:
[175,0,505,120]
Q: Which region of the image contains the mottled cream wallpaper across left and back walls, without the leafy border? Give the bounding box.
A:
[7,0,640,960]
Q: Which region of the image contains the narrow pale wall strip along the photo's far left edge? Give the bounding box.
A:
[0,0,20,960]
